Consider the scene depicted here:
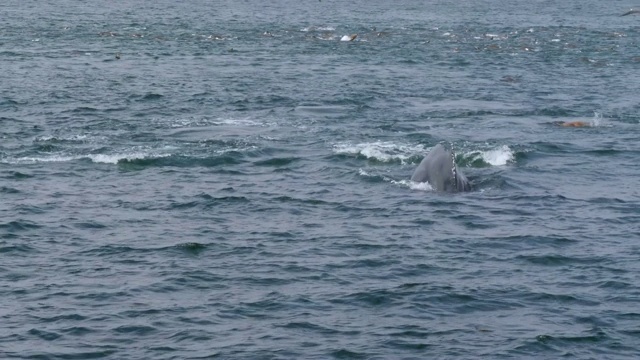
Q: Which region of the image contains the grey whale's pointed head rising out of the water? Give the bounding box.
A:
[411,144,471,192]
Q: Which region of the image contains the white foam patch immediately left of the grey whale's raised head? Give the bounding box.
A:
[333,141,424,163]
